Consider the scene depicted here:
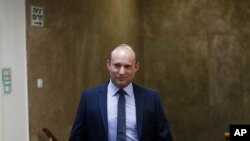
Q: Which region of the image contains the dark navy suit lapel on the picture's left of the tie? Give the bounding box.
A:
[99,85,108,135]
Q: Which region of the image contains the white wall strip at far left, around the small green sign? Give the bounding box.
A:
[0,0,29,141]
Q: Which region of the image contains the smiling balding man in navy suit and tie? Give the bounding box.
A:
[69,44,172,141]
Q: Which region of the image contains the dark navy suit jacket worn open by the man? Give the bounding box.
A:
[69,84,172,141]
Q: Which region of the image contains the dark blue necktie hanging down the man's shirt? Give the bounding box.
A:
[117,89,126,141]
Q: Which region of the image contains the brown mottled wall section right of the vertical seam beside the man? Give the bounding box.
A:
[143,0,250,141]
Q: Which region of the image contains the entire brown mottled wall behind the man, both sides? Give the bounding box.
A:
[27,0,250,141]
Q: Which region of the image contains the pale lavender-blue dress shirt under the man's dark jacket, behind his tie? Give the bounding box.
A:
[107,80,138,141]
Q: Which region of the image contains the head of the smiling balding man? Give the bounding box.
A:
[107,44,139,89]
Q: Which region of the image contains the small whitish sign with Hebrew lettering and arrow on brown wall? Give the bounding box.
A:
[31,6,44,27]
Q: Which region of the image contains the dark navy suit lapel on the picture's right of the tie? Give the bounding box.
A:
[133,84,144,140]
